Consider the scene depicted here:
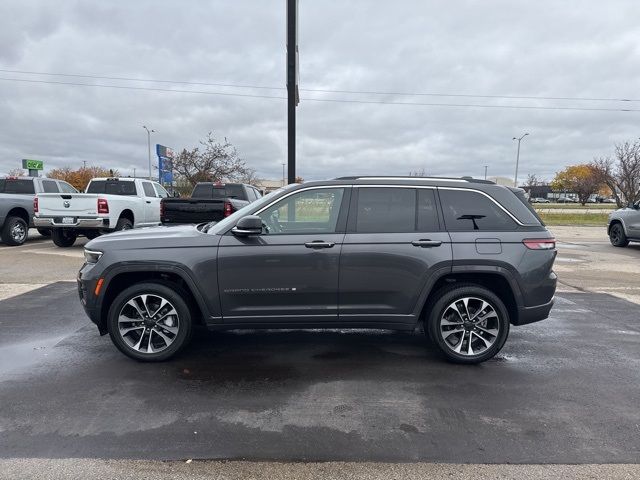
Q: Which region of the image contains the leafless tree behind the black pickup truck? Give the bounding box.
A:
[173,132,247,185]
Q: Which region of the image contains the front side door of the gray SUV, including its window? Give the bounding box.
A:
[218,187,350,323]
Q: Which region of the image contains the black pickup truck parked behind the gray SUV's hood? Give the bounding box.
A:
[160,182,262,225]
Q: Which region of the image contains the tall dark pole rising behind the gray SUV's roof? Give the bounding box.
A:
[286,0,300,183]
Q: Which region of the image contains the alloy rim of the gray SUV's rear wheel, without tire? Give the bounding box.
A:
[440,297,500,357]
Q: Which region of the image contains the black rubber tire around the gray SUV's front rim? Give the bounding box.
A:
[107,282,193,362]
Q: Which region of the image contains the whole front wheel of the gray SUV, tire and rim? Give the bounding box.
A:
[107,283,192,362]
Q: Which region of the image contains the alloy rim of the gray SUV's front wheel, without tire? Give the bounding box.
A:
[118,293,180,354]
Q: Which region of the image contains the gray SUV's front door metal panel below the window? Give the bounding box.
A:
[218,233,344,323]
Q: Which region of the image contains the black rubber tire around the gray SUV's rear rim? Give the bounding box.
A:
[426,284,509,364]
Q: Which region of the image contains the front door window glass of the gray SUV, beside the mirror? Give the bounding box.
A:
[258,188,344,235]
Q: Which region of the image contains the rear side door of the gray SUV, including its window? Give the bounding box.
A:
[339,186,452,323]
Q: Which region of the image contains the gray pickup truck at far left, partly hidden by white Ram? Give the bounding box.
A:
[0,177,78,246]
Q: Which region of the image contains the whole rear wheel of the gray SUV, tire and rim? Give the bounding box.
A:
[427,284,509,364]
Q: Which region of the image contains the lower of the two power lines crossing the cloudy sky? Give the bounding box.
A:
[0,77,640,112]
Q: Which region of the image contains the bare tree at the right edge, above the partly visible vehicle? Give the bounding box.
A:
[591,141,640,207]
